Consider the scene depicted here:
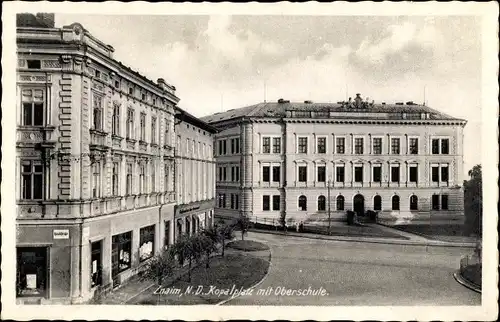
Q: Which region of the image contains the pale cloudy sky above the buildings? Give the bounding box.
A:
[56,14,482,172]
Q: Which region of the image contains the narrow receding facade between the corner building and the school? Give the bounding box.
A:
[175,108,217,240]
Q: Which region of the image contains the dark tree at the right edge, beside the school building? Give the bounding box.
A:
[464,164,483,235]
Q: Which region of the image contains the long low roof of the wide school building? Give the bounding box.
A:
[201,101,460,123]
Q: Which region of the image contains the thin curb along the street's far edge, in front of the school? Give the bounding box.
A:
[250,229,475,248]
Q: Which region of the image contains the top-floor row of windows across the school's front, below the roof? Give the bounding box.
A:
[254,136,450,154]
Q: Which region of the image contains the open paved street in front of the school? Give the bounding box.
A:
[226,233,481,305]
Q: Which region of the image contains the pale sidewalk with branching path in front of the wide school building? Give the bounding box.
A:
[250,224,475,248]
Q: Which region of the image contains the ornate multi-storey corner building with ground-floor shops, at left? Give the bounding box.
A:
[16,14,179,303]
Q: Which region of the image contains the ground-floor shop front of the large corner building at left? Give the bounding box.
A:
[16,204,174,304]
